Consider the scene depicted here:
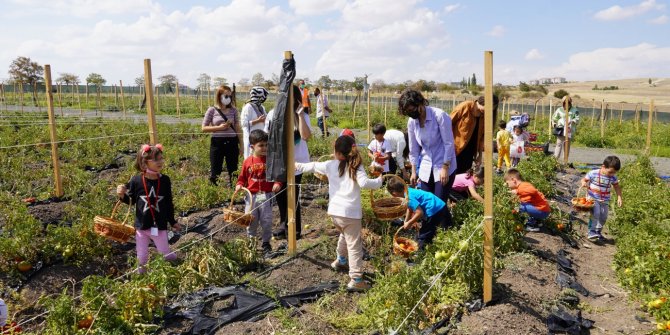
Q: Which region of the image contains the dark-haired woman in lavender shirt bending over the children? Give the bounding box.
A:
[398,89,456,230]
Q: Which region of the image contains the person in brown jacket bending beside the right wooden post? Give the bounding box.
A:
[451,95,498,173]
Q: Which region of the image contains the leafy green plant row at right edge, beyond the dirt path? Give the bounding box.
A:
[608,157,670,334]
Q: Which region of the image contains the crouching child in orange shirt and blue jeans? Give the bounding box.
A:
[505,168,551,232]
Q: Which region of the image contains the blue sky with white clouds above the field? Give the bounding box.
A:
[0,0,670,85]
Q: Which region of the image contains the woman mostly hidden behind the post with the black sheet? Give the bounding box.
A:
[265,86,312,238]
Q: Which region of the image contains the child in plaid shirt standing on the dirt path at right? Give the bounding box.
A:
[582,156,623,242]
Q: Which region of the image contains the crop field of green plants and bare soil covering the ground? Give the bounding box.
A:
[0,94,670,334]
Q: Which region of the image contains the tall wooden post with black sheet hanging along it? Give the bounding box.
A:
[284,51,297,254]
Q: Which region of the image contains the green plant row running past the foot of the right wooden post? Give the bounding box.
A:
[320,154,560,334]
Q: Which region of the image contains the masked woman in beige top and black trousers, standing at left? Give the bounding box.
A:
[202,86,242,186]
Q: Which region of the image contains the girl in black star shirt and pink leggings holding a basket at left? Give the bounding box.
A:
[116,144,180,273]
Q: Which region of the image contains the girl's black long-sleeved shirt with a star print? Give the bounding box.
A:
[122,175,177,230]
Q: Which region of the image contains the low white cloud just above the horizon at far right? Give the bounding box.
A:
[545,43,670,80]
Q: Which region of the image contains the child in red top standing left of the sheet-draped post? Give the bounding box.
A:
[235,129,281,254]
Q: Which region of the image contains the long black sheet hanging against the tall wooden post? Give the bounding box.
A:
[266,57,295,182]
